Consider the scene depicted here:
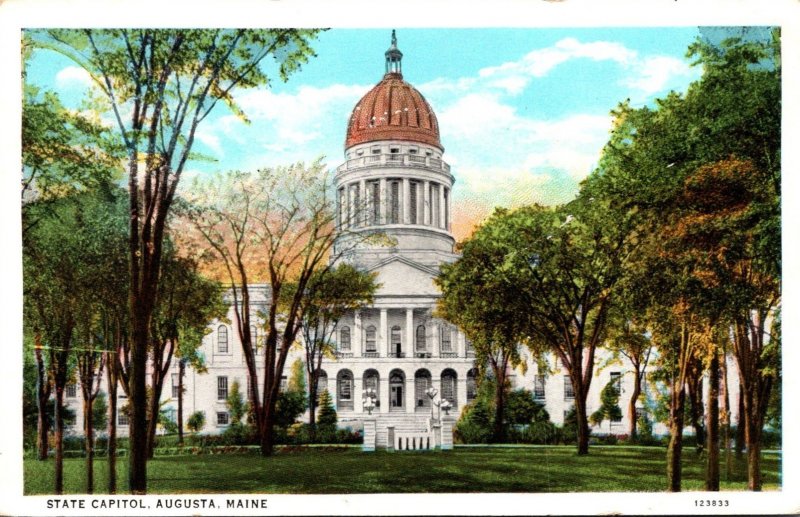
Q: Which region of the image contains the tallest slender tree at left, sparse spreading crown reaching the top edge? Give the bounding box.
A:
[32,29,317,494]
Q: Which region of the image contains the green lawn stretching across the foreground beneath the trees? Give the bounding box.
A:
[24,446,780,495]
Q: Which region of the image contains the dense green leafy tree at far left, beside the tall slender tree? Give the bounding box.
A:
[23,188,122,493]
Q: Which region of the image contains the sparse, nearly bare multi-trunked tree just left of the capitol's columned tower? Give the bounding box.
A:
[183,161,382,456]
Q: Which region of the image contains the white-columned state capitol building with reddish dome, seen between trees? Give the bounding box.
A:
[66,33,736,447]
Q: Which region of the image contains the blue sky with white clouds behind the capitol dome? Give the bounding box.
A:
[27,27,701,239]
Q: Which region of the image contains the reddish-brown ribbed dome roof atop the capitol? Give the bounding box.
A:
[344,72,442,149]
